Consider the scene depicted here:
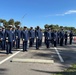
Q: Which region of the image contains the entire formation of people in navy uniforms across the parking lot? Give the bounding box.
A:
[0,25,73,54]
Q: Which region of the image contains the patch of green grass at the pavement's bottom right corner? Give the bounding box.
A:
[53,64,76,75]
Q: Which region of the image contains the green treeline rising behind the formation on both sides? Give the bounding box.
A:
[0,19,76,34]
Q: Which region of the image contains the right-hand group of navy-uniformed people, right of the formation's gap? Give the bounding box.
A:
[44,28,73,48]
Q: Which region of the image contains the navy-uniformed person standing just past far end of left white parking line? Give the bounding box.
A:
[22,27,29,51]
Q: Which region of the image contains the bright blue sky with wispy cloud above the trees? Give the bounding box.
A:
[0,0,76,28]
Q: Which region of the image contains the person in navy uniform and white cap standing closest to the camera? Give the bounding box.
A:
[6,26,13,54]
